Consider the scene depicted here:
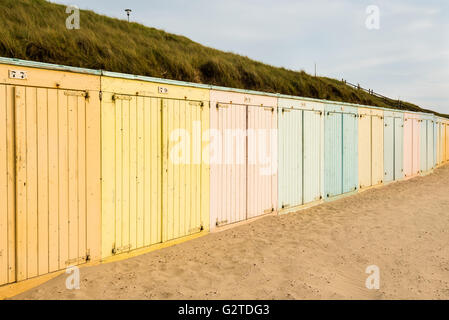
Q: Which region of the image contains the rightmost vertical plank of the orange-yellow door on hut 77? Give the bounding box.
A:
[76,97,86,258]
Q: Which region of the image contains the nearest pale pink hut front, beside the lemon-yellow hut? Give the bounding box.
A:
[210,90,277,228]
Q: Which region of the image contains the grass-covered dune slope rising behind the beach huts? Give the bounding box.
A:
[0,0,444,117]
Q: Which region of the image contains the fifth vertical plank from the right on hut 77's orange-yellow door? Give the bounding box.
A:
[37,88,49,275]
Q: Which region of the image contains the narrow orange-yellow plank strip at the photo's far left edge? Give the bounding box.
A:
[0,85,10,286]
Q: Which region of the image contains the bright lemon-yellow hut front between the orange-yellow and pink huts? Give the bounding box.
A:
[101,77,209,258]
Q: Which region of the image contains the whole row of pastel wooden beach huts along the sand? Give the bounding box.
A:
[0,58,449,286]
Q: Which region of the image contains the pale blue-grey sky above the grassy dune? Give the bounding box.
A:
[52,0,449,114]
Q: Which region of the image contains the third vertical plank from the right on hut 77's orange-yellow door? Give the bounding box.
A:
[58,90,69,269]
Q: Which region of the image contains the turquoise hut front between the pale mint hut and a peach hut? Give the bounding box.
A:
[324,105,358,198]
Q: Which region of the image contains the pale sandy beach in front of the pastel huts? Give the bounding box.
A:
[10,165,449,299]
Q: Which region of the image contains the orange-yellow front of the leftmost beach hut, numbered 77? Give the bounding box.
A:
[0,65,101,285]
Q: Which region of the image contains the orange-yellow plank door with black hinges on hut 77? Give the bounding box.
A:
[13,86,90,281]
